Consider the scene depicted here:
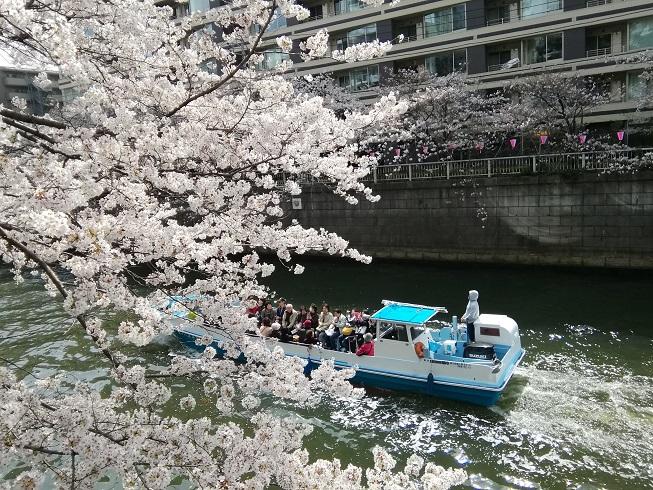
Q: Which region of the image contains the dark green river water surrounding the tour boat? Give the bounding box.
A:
[0,261,653,489]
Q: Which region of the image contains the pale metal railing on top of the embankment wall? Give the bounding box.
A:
[279,148,653,185]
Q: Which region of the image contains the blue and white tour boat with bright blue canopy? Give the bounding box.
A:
[170,300,525,406]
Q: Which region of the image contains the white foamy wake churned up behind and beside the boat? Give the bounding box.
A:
[288,326,653,489]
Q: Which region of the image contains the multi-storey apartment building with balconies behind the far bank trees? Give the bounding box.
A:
[168,0,653,130]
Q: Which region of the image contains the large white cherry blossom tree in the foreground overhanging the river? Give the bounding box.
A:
[0,0,466,489]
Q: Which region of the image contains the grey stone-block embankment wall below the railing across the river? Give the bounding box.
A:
[289,172,653,268]
